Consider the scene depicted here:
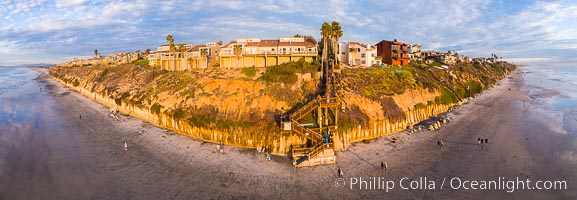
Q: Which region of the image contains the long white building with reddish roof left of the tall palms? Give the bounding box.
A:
[218,37,318,68]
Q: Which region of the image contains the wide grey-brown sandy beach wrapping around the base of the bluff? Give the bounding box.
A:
[0,68,577,199]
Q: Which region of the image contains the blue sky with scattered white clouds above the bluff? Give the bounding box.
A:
[0,0,577,66]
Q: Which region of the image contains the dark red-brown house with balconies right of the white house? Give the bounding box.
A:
[376,39,409,66]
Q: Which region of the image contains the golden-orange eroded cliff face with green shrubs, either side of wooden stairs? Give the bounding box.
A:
[50,61,514,154]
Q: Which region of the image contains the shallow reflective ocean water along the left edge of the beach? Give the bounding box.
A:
[0,67,63,178]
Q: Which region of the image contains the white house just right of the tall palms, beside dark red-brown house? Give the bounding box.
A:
[339,42,381,67]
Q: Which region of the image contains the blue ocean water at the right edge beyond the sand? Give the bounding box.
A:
[523,65,577,136]
